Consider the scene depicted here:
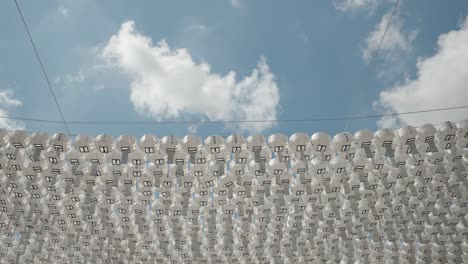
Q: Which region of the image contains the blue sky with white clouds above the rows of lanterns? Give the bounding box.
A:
[0,0,468,136]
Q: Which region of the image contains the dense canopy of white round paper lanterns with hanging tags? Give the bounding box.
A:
[0,121,468,263]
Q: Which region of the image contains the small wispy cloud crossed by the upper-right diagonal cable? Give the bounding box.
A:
[362,12,417,63]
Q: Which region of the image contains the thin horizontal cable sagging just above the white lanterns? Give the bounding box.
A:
[0,105,468,125]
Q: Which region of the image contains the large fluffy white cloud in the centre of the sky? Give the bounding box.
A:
[101,21,279,132]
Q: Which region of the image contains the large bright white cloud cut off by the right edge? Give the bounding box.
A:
[375,17,468,127]
